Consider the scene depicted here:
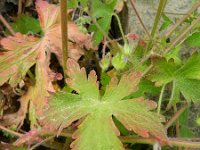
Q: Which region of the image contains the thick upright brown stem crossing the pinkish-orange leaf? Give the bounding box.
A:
[60,0,68,77]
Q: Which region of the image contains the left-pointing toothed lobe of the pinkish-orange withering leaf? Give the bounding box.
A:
[0,33,38,87]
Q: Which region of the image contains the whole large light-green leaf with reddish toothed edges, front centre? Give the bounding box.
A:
[40,59,167,150]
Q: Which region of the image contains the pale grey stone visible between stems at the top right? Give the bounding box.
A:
[128,0,193,35]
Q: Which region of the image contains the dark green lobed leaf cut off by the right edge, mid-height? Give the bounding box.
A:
[149,53,200,102]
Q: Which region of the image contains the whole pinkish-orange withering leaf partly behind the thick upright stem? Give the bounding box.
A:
[0,0,92,126]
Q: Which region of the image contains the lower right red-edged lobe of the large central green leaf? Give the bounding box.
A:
[113,99,166,141]
